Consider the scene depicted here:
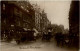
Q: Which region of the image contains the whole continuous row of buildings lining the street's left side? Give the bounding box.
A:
[1,1,50,39]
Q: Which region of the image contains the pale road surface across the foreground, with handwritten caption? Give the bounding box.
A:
[0,38,77,51]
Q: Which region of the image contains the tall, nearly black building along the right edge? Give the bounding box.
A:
[69,1,79,47]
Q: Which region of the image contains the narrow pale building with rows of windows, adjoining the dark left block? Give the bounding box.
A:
[34,4,41,31]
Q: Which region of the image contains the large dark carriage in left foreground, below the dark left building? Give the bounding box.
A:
[14,29,35,44]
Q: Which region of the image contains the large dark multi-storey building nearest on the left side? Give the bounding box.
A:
[1,1,35,39]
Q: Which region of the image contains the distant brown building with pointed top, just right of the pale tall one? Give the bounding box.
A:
[41,10,51,31]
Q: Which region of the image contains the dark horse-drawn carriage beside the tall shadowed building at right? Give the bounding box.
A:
[55,33,69,46]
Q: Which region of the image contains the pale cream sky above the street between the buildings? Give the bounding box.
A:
[30,0,71,29]
